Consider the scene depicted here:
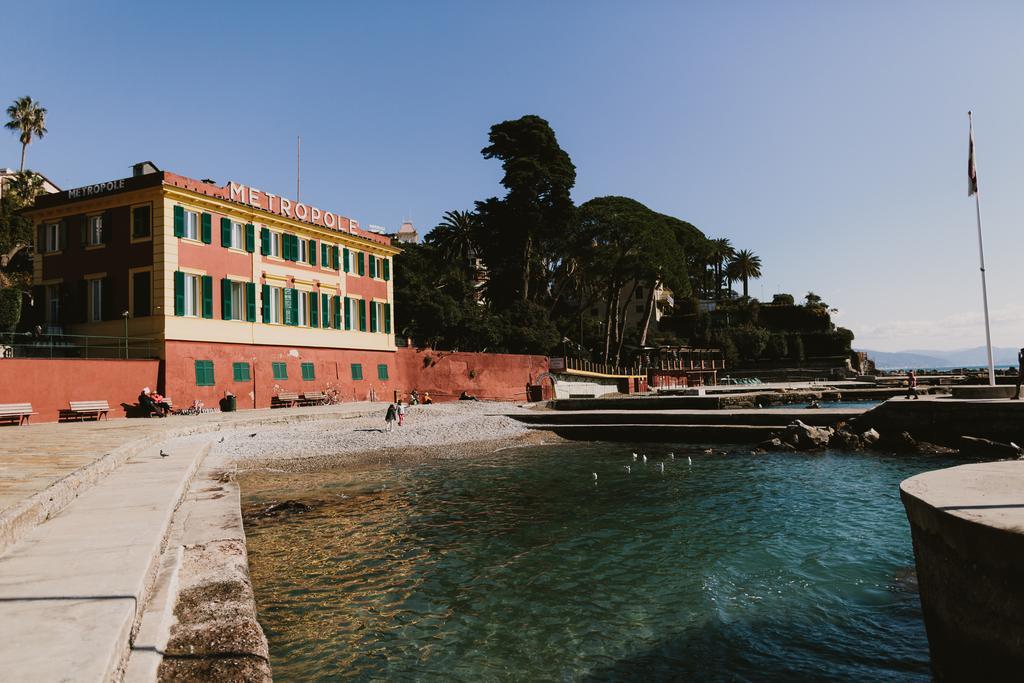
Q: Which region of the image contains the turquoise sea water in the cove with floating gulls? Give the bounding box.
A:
[244,443,954,681]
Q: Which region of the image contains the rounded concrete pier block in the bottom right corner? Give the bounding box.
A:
[900,461,1024,681]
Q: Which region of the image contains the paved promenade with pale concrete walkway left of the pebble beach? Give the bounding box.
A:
[0,403,380,681]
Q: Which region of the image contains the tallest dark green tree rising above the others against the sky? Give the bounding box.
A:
[477,115,575,307]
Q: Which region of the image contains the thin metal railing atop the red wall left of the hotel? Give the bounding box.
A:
[0,332,160,359]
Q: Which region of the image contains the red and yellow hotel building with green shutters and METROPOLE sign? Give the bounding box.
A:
[26,162,400,408]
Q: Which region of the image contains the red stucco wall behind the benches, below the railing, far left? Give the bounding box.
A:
[0,358,160,422]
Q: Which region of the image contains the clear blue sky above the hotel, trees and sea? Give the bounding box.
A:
[0,1,1024,350]
